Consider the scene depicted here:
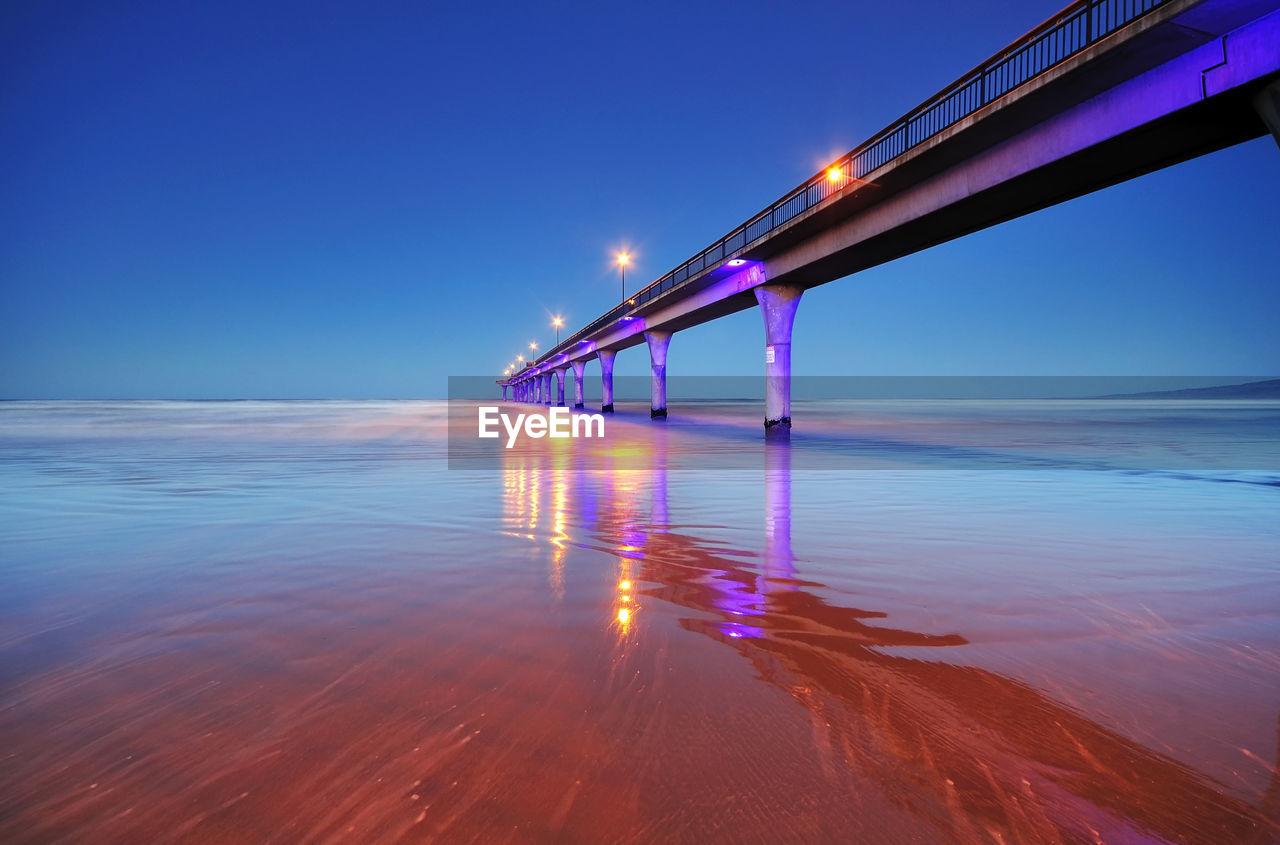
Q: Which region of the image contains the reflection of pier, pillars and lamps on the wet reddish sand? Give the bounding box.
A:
[508,443,1280,844]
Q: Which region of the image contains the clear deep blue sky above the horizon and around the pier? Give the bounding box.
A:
[0,0,1280,398]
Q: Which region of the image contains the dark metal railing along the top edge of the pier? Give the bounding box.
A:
[536,0,1171,373]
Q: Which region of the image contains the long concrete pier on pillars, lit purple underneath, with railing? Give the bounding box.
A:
[498,0,1280,433]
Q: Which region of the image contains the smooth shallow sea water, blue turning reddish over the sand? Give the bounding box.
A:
[0,401,1280,842]
